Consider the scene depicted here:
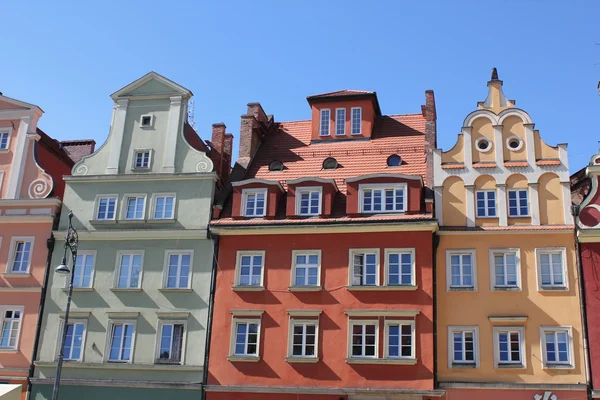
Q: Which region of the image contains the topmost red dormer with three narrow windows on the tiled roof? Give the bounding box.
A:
[306,90,381,142]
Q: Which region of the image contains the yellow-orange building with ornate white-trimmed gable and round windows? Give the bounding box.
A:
[433,69,586,400]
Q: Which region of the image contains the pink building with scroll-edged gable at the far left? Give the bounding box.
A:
[0,95,93,399]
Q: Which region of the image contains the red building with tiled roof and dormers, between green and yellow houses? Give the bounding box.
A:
[205,91,443,400]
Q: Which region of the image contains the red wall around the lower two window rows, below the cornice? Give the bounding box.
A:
[208,232,433,390]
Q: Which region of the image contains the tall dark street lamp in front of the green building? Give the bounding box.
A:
[52,212,79,400]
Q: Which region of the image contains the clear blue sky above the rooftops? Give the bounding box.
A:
[0,0,600,172]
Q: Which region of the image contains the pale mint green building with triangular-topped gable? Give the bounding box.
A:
[31,73,222,400]
